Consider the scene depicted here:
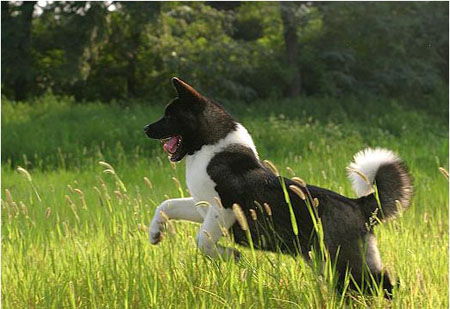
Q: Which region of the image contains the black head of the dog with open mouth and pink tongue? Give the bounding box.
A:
[144,77,236,162]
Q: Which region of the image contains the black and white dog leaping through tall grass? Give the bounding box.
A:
[145,78,412,293]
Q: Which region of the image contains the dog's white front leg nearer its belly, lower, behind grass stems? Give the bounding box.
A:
[197,206,239,260]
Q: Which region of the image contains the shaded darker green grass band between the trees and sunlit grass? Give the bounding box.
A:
[1,94,448,169]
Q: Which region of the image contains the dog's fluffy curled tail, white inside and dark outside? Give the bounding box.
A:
[347,148,413,221]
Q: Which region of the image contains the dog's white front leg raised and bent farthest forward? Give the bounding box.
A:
[149,197,203,245]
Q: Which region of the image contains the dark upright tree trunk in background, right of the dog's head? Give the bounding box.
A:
[280,1,302,97]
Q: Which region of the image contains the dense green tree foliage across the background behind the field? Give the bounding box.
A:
[2,1,448,104]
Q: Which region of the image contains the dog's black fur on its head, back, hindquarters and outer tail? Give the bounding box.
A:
[145,79,412,295]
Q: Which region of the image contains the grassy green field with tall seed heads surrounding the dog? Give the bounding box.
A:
[1,96,449,308]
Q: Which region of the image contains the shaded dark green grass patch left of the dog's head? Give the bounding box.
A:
[2,95,163,169]
